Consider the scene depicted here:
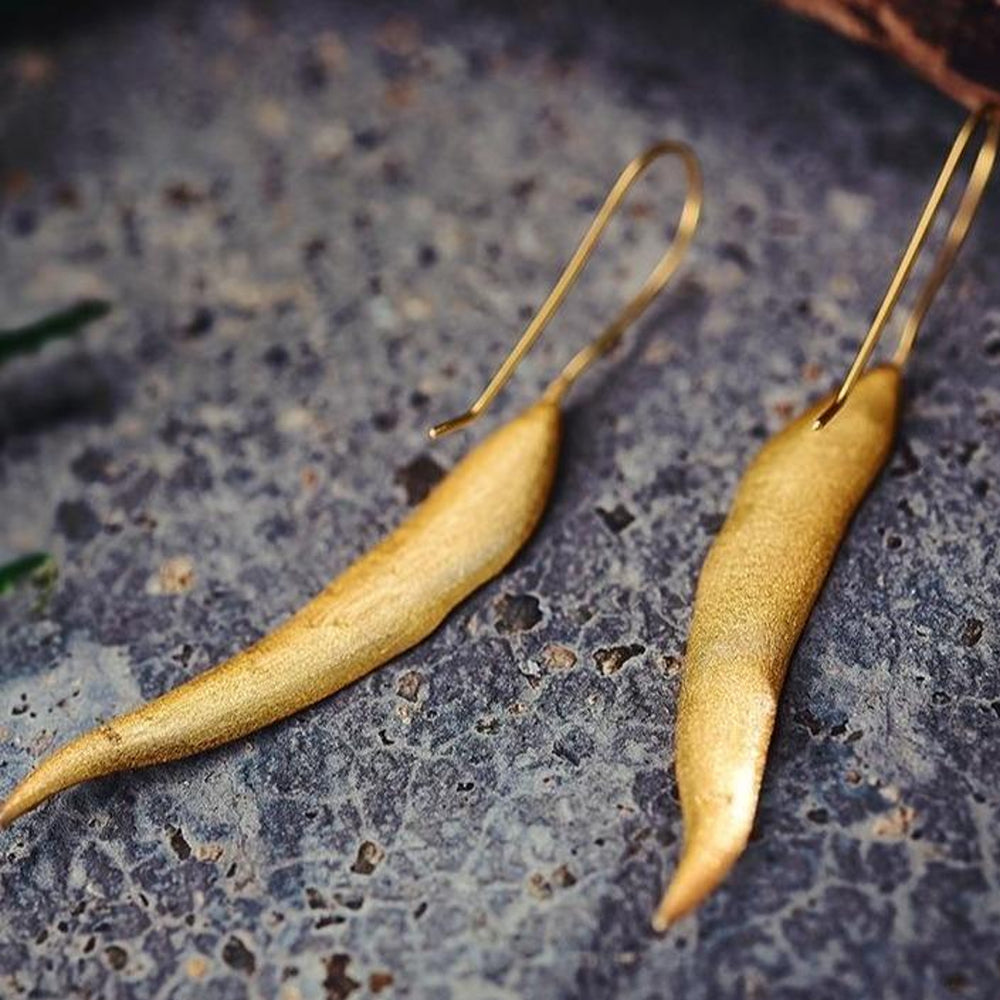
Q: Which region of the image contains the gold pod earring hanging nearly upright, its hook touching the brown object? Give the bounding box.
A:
[653,108,1000,931]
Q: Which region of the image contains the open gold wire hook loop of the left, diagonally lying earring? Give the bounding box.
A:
[430,140,704,438]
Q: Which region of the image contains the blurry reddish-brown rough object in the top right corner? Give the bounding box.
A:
[778,0,1000,108]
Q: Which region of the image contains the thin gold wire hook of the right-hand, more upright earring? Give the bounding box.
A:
[813,104,1000,430]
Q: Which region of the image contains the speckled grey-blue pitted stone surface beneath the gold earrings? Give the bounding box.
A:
[0,0,1000,1000]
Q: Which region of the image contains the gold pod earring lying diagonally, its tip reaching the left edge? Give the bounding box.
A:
[0,142,702,825]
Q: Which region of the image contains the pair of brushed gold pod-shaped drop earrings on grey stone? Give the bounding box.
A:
[0,108,1000,930]
